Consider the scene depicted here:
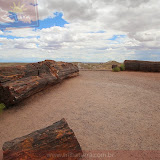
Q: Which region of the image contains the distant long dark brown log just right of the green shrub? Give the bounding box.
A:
[124,60,160,72]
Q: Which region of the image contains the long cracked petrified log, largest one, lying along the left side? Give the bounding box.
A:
[0,60,79,107]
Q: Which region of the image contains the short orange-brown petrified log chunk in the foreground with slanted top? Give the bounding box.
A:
[3,119,83,160]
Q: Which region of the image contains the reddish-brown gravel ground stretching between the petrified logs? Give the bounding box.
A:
[0,71,160,156]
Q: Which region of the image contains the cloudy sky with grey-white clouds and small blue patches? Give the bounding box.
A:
[0,0,160,62]
